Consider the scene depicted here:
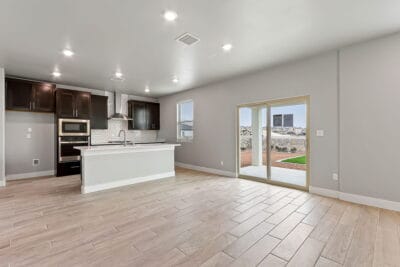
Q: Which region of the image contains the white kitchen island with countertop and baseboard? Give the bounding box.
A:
[74,144,180,194]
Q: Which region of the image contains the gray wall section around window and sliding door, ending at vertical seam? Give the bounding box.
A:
[160,52,339,190]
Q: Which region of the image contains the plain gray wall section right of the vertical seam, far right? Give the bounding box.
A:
[340,34,400,201]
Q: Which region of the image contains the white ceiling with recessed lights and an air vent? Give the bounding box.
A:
[0,0,400,96]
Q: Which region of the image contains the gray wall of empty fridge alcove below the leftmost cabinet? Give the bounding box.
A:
[5,111,55,175]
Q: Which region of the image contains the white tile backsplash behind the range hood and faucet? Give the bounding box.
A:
[91,120,158,144]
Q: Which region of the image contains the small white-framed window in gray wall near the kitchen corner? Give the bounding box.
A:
[176,100,193,141]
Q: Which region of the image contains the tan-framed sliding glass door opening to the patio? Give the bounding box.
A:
[238,97,309,189]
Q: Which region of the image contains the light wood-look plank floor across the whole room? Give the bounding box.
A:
[0,169,400,267]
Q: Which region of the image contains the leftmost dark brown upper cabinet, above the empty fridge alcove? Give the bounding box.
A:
[6,78,55,112]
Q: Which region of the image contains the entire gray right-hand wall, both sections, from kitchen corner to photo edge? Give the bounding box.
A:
[160,31,400,201]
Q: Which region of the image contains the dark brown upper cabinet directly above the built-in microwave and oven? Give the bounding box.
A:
[56,89,91,120]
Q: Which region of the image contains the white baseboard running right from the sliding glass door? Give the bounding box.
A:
[309,186,400,211]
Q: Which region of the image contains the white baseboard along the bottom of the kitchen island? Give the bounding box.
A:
[81,171,175,194]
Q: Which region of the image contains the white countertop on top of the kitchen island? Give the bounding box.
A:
[74,143,180,156]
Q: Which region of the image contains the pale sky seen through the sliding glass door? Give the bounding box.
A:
[239,104,307,128]
